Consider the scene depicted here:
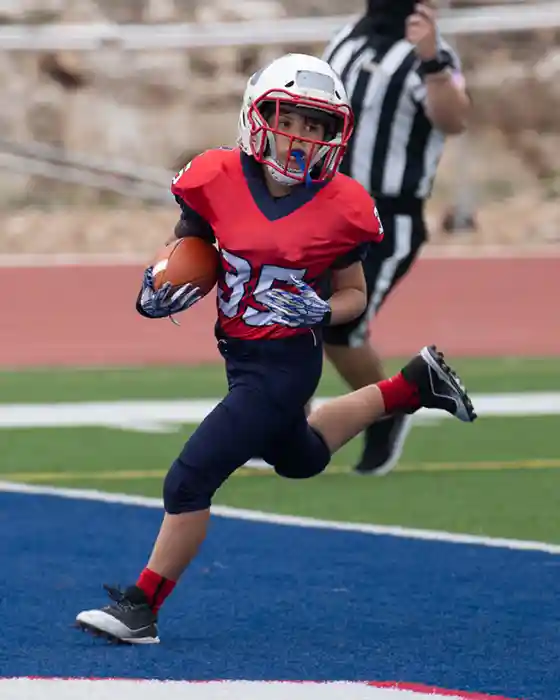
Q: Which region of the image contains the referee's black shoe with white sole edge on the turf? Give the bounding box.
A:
[354,415,412,476]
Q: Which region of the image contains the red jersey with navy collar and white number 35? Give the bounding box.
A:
[171,148,383,340]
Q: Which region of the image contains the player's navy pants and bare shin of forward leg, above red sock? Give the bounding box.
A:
[144,333,322,580]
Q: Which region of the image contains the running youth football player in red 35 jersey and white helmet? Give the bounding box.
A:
[77,54,476,644]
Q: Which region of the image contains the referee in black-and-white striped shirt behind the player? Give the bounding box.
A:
[323,0,470,475]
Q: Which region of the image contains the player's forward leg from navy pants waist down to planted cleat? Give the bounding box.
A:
[77,334,322,643]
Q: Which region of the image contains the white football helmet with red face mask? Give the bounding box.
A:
[238,53,354,185]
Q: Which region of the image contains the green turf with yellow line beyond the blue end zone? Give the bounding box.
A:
[0,359,560,542]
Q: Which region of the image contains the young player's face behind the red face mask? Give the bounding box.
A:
[269,107,325,168]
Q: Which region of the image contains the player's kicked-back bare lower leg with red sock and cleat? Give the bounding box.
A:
[308,346,476,454]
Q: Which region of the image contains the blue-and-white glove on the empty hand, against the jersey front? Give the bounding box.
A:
[258,276,331,328]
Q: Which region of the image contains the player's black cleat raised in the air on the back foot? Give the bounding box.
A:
[402,345,477,423]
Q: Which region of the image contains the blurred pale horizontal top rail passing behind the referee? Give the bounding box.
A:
[0,0,560,51]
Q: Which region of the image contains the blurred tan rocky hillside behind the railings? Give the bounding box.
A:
[0,0,560,252]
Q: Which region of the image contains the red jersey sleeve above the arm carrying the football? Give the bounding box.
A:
[171,149,228,223]
